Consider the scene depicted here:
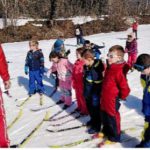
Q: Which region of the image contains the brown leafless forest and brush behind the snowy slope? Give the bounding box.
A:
[0,0,150,42]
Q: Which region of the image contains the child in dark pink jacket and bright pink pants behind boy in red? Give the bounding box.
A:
[125,33,137,68]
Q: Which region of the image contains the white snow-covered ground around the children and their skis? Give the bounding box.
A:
[2,25,150,148]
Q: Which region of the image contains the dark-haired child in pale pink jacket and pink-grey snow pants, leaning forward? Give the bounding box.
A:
[48,51,73,108]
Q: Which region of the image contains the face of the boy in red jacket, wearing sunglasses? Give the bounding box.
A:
[107,51,121,65]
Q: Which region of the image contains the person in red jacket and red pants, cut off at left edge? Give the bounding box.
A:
[0,45,10,148]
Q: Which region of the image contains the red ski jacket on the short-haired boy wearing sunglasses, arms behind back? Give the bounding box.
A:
[100,62,130,116]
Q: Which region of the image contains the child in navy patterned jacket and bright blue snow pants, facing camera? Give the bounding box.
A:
[25,41,45,96]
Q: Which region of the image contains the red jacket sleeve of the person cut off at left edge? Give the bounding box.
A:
[0,44,10,81]
